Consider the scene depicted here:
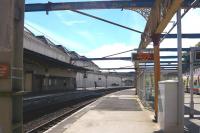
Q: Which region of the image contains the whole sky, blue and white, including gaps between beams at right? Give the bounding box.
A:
[25,0,200,71]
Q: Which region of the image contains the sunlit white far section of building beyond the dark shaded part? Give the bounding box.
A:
[69,51,130,88]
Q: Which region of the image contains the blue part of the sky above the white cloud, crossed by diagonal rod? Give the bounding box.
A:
[25,0,146,54]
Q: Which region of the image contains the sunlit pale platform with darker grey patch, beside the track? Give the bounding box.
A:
[45,89,159,133]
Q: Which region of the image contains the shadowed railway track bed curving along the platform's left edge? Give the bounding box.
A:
[24,89,132,133]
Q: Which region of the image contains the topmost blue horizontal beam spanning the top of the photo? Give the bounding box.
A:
[25,0,154,12]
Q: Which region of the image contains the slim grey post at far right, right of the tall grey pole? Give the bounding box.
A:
[190,50,194,118]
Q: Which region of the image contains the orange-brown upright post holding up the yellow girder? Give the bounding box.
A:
[152,34,160,122]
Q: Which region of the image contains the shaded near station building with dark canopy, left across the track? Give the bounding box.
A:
[24,30,86,92]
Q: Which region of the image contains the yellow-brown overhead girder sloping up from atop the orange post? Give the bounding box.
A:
[139,0,183,49]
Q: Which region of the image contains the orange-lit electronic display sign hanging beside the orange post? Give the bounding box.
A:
[131,53,154,61]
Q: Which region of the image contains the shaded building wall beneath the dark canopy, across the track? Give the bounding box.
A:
[24,62,76,92]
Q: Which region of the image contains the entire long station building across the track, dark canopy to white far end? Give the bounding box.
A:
[23,29,133,92]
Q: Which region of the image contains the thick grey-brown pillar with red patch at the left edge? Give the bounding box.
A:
[0,0,24,133]
